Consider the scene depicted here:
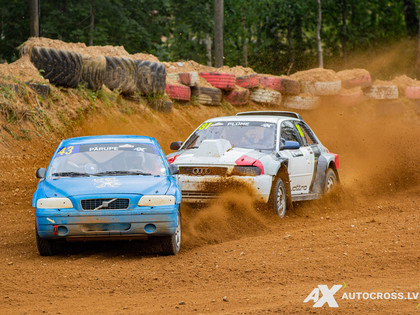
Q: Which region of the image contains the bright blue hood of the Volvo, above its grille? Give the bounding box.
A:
[42,176,171,197]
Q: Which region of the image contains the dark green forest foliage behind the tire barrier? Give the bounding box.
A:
[0,0,420,74]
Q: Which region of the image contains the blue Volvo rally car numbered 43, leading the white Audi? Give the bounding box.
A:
[32,136,181,256]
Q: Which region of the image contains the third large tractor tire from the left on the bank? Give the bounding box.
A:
[104,57,137,95]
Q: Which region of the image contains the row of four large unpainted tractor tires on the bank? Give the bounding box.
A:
[29,46,166,95]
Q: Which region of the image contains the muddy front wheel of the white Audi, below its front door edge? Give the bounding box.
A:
[268,175,292,218]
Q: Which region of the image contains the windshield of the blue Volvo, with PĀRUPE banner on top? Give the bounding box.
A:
[48,143,166,178]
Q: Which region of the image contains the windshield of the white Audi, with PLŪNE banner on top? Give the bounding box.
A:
[183,121,277,150]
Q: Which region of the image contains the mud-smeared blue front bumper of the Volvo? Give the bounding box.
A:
[36,205,179,239]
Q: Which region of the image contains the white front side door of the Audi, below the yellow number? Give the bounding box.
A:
[280,120,314,195]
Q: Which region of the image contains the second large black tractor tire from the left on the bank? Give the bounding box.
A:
[82,56,106,91]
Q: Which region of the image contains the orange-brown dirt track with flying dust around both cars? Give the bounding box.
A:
[0,100,420,314]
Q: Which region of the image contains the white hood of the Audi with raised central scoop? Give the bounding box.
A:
[173,140,268,166]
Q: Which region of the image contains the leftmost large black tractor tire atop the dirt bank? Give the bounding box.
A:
[30,46,82,88]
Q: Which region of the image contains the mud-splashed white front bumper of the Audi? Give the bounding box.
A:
[178,174,273,203]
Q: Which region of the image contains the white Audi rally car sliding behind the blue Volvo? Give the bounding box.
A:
[168,111,339,217]
